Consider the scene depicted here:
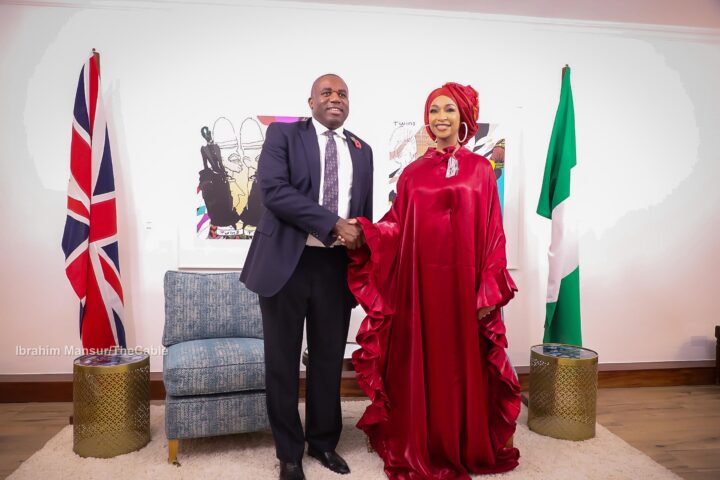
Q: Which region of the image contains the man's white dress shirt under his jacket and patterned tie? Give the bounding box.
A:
[305,118,352,247]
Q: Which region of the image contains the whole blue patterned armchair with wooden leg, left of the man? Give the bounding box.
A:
[163,271,268,463]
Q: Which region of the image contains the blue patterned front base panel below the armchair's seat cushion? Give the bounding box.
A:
[165,392,268,439]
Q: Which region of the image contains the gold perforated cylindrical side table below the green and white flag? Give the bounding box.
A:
[528,343,598,440]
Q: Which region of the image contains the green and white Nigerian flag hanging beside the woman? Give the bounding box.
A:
[537,67,582,346]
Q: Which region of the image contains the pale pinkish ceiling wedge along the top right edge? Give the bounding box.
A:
[286,0,720,29]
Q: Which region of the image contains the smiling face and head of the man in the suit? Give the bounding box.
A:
[308,75,350,130]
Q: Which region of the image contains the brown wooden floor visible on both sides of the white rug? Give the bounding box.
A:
[0,385,720,480]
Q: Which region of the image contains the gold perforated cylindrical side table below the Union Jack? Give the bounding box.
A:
[73,354,150,458]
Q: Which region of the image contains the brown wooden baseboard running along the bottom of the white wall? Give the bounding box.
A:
[0,361,716,403]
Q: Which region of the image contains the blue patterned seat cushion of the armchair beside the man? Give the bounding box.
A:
[163,338,265,396]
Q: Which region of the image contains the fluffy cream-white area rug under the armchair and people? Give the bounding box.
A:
[8,400,680,480]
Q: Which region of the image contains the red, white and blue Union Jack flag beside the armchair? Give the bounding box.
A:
[62,53,126,350]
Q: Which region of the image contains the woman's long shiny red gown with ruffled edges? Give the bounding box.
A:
[348,148,520,480]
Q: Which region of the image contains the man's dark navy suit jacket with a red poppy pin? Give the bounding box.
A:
[240,120,373,297]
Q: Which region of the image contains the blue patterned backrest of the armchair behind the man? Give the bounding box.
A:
[163,271,262,347]
